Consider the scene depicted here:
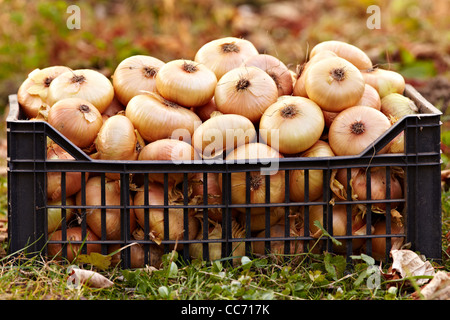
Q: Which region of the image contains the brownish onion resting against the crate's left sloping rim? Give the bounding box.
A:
[48,98,103,148]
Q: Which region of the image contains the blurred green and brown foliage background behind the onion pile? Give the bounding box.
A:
[0,0,450,112]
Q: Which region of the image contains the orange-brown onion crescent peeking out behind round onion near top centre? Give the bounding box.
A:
[241,54,293,96]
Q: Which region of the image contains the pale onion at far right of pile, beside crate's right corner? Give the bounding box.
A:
[381,93,419,120]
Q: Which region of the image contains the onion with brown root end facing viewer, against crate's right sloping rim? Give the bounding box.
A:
[328,106,391,156]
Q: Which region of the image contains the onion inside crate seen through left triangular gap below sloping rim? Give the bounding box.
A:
[47,144,89,201]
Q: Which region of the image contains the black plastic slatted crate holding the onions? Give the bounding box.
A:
[7,85,442,268]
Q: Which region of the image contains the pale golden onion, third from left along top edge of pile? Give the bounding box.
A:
[112,55,164,106]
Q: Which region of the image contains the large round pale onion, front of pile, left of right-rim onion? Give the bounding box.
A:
[259,96,325,154]
